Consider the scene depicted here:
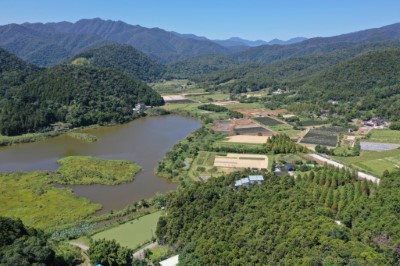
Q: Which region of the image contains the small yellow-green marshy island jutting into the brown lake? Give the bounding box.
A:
[56,156,142,185]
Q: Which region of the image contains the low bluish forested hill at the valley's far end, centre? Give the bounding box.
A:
[166,55,237,78]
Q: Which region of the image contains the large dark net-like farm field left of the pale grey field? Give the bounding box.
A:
[300,127,345,147]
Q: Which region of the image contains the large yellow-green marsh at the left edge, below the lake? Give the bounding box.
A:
[0,172,101,232]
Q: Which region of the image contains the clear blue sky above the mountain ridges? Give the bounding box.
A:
[0,0,400,40]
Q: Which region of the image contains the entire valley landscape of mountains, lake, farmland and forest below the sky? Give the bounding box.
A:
[0,14,400,265]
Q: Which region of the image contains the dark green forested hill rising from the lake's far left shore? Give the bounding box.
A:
[0,65,164,135]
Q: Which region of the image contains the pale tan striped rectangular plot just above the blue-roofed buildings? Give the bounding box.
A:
[214,153,268,170]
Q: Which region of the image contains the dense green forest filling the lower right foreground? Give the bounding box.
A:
[157,166,400,265]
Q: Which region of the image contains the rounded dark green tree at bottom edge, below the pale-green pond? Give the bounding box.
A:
[88,239,147,266]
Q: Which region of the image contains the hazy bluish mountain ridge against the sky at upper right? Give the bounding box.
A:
[233,23,400,63]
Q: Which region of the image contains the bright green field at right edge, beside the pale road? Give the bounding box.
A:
[334,149,400,177]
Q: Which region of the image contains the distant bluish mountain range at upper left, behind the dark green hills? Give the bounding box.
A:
[0,18,230,66]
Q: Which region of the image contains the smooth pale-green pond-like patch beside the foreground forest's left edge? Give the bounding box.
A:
[92,211,161,249]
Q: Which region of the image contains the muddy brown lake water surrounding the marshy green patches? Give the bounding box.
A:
[0,116,201,212]
